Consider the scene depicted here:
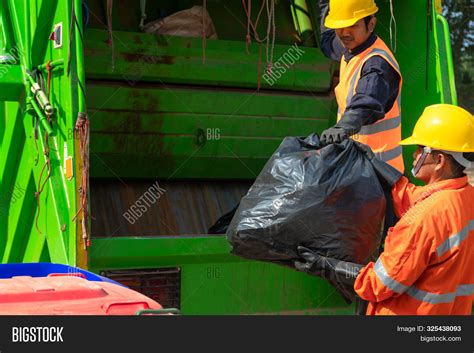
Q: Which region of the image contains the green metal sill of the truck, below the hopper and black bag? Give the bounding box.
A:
[90,236,354,315]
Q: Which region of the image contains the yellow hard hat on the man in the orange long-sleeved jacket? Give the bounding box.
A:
[400,104,474,152]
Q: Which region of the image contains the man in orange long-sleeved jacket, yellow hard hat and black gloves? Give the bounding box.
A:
[295,104,474,315]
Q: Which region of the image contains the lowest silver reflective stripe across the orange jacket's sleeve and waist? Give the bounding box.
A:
[374,259,474,304]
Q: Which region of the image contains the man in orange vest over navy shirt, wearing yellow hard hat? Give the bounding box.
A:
[320,0,404,172]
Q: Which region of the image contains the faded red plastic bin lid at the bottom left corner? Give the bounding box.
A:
[0,276,162,315]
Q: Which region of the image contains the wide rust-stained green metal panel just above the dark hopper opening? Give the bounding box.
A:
[88,82,336,179]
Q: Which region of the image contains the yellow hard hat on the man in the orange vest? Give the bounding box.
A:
[324,0,379,28]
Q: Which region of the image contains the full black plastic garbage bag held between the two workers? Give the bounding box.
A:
[227,135,386,301]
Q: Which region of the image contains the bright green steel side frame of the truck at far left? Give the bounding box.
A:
[0,0,84,265]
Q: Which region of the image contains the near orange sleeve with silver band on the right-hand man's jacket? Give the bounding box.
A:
[354,206,438,302]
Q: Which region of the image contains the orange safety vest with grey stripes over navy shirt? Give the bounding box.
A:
[335,38,405,173]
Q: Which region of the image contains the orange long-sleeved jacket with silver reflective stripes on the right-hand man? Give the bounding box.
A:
[354,177,474,315]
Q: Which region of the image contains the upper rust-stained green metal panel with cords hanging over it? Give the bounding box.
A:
[84,29,335,93]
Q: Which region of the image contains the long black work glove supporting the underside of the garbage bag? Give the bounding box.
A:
[294,246,364,286]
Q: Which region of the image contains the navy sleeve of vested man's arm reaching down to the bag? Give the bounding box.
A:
[337,55,400,133]
